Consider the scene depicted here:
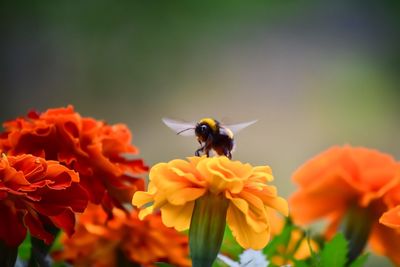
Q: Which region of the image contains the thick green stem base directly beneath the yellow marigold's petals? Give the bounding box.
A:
[189,193,229,267]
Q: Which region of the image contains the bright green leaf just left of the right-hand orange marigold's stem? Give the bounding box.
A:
[321,233,347,267]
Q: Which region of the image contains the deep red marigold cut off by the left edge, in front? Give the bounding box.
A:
[0,155,88,246]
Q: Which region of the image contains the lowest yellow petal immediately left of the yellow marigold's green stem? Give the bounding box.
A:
[161,201,194,231]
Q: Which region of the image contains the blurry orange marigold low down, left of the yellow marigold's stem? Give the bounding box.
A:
[54,205,190,267]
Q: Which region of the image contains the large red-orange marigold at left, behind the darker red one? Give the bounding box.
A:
[0,106,147,210]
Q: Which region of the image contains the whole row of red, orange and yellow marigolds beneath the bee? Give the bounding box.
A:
[0,103,400,267]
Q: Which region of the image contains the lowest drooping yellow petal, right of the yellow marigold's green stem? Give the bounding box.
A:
[226,204,270,250]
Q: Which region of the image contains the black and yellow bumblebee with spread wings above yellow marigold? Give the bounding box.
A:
[162,118,257,159]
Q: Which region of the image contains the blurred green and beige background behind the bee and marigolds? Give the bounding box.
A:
[0,0,400,267]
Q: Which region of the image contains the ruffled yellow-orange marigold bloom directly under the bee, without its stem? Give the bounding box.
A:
[132,156,288,249]
